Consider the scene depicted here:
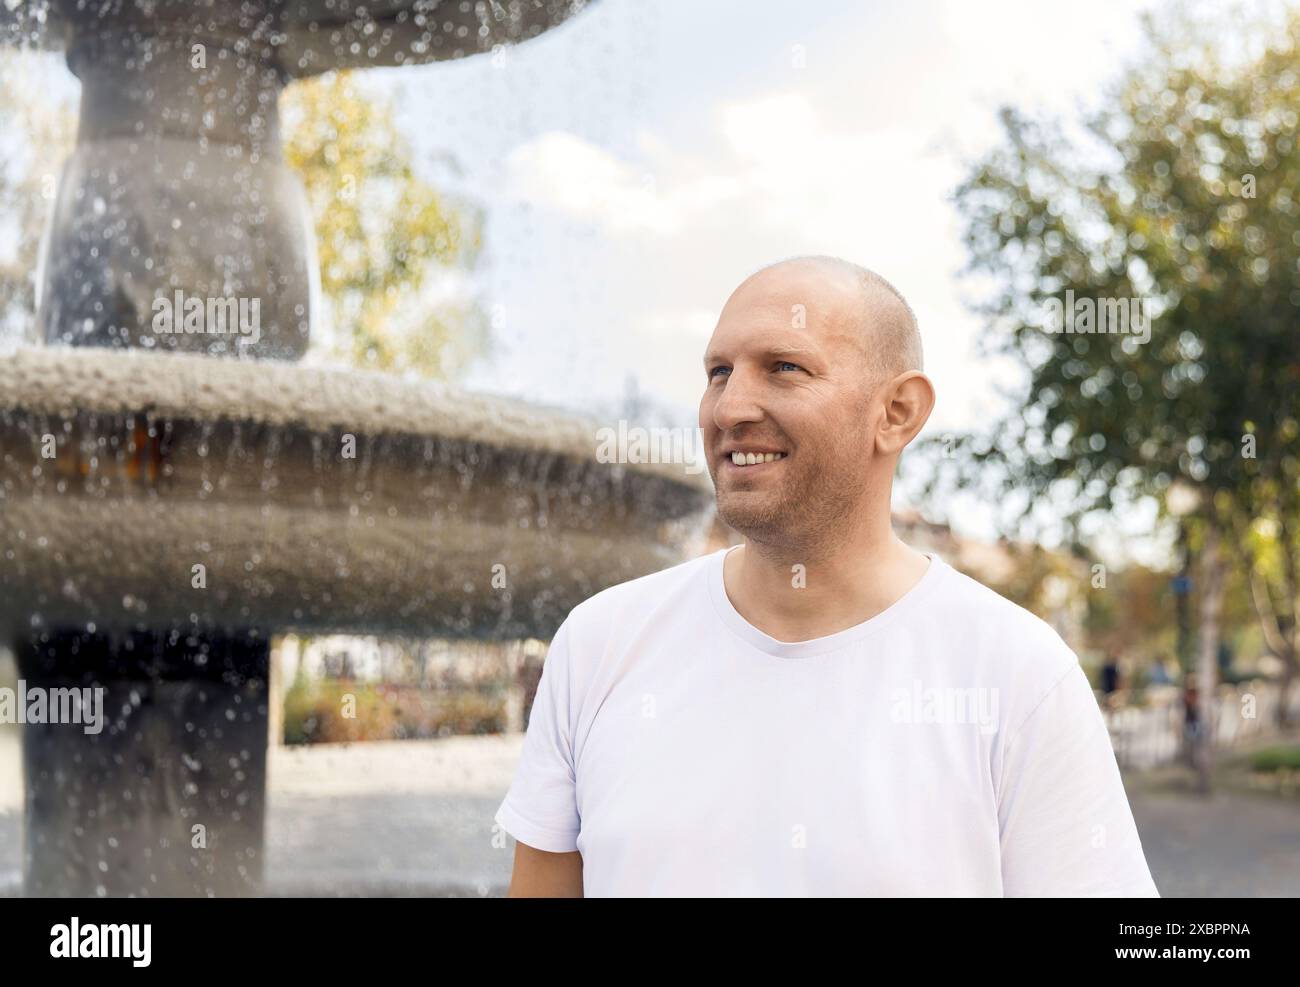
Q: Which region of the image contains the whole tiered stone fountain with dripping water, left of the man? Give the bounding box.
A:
[0,0,711,896]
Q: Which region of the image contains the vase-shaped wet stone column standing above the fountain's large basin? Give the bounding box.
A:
[36,23,317,359]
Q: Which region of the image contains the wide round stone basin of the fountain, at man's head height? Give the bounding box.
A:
[0,347,711,637]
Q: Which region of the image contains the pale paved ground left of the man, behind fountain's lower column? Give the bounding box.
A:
[0,730,523,896]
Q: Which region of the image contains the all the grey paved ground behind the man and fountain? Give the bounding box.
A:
[0,730,1300,897]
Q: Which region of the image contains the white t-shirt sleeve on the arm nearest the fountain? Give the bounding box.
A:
[494,624,579,853]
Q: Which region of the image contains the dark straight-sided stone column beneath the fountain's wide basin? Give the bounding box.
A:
[18,631,269,897]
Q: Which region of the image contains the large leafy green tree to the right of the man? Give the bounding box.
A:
[931,13,1300,771]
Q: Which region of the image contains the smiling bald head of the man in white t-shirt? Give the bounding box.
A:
[699,256,935,547]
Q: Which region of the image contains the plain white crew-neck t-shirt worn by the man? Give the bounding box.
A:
[495,549,1158,897]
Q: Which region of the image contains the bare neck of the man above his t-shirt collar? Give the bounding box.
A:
[723,519,931,641]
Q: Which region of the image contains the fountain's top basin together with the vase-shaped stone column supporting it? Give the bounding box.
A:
[0,0,595,360]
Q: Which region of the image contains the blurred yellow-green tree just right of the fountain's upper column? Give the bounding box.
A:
[281,72,488,377]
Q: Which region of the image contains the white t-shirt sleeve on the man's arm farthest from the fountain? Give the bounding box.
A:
[998,658,1160,897]
